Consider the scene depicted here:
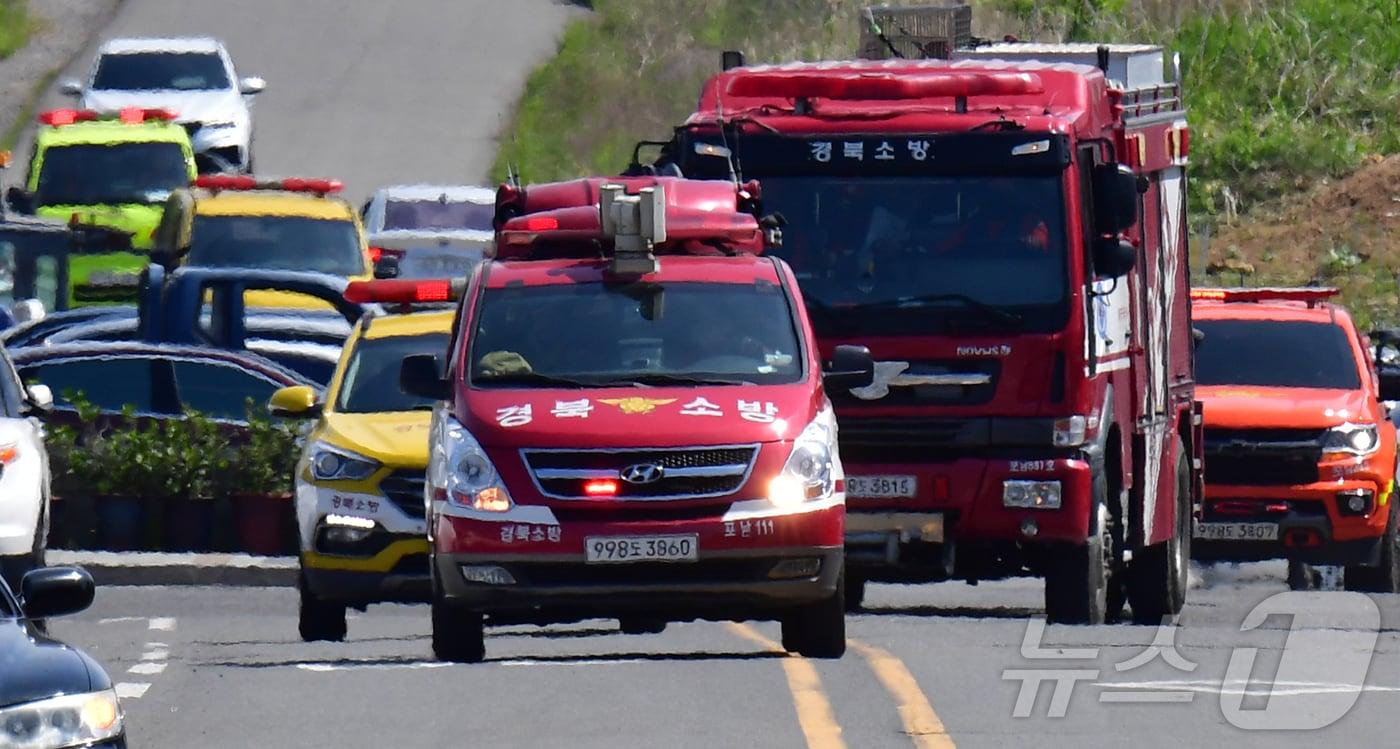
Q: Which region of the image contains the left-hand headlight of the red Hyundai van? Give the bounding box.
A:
[426,412,512,512]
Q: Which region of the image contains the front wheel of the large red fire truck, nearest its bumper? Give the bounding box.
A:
[1046,470,1123,624]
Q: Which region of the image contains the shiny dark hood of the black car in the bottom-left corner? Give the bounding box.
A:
[0,617,112,707]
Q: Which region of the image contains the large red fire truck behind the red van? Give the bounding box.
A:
[627,42,1201,623]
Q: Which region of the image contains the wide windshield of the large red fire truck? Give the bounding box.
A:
[762,175,1068,335]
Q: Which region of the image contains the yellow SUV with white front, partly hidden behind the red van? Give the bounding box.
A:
[267,294,455,641]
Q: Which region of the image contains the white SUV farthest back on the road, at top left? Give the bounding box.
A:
[60,36,266,174]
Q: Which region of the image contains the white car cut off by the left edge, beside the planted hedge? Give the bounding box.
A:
[0,347,53,591]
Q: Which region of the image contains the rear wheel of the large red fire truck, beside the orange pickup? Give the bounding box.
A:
[1128,437,1191,624]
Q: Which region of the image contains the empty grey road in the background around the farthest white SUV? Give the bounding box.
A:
[7,0,581,203]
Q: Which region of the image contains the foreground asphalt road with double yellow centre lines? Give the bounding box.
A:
[52,566,1400,749]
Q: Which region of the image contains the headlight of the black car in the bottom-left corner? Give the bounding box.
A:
[0,689,122,749]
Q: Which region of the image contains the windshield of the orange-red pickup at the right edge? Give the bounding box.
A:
[1194,319,1361,391]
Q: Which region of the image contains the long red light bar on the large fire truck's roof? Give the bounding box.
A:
[725,70,1044,101]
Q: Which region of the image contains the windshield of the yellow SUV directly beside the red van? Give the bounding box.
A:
[336,333,448,413]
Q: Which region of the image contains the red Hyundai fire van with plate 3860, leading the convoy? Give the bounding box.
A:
[400,178,872,661]
